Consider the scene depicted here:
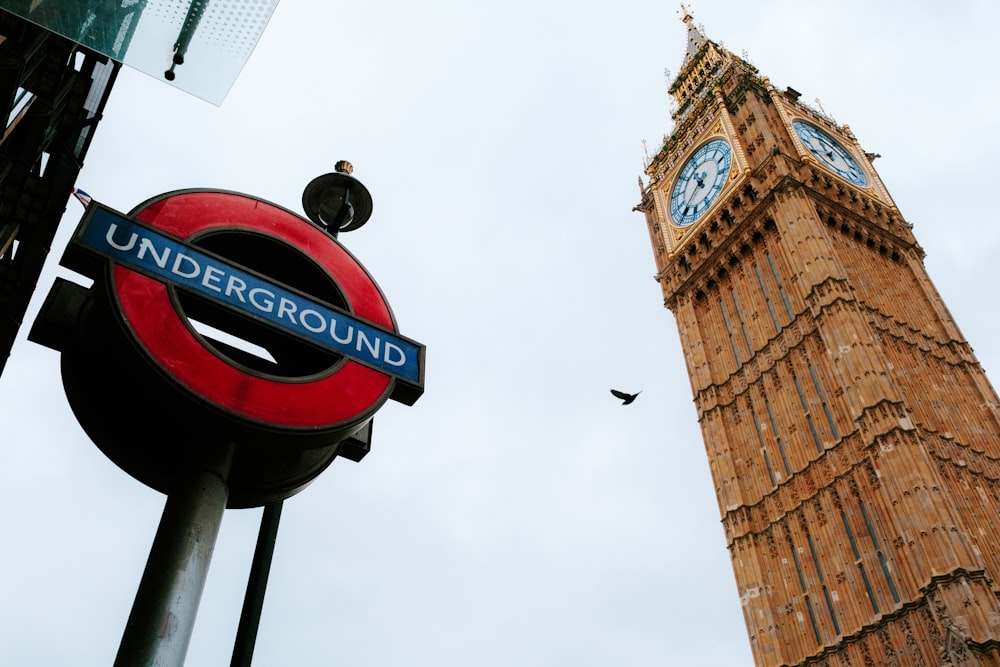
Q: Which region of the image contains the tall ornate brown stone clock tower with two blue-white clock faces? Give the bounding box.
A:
[637,6,1000,667]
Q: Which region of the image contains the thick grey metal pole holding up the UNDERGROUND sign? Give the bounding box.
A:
[115,446,232,667]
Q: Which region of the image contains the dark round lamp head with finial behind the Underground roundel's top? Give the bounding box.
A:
[302,160,372,238]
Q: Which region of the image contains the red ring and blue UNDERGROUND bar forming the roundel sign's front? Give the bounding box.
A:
[73,192,423,422]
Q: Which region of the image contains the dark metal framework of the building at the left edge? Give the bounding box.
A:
[0,10,121,373]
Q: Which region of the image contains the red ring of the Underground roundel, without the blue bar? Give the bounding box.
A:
[112,191,396,429]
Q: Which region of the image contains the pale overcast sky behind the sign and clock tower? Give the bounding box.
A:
[0,0,1000,667]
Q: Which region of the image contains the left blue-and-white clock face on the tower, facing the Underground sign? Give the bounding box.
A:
[670,139,733,226]
